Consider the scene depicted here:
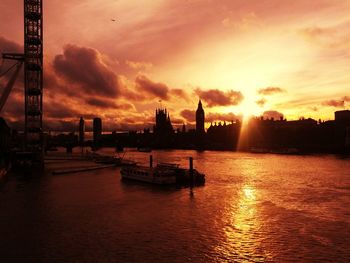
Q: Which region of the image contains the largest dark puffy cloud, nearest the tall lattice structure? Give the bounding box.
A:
[53,45,121,97]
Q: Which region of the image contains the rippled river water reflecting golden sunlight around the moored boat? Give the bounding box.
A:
[0,150,350,262]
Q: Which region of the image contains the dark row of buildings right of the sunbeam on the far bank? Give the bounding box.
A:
[244,110,350,153]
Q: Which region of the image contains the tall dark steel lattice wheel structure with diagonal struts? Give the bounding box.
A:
[0,0,43,164]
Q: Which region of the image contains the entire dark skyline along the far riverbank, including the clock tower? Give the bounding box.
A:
[40,103,350,156]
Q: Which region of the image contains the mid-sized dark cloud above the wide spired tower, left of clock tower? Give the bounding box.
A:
[135,75,169,100]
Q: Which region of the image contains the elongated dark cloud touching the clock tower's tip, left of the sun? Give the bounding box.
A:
[195,89,244,107]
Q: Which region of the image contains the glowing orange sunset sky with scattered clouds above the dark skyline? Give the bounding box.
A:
[0,0,350,130]
